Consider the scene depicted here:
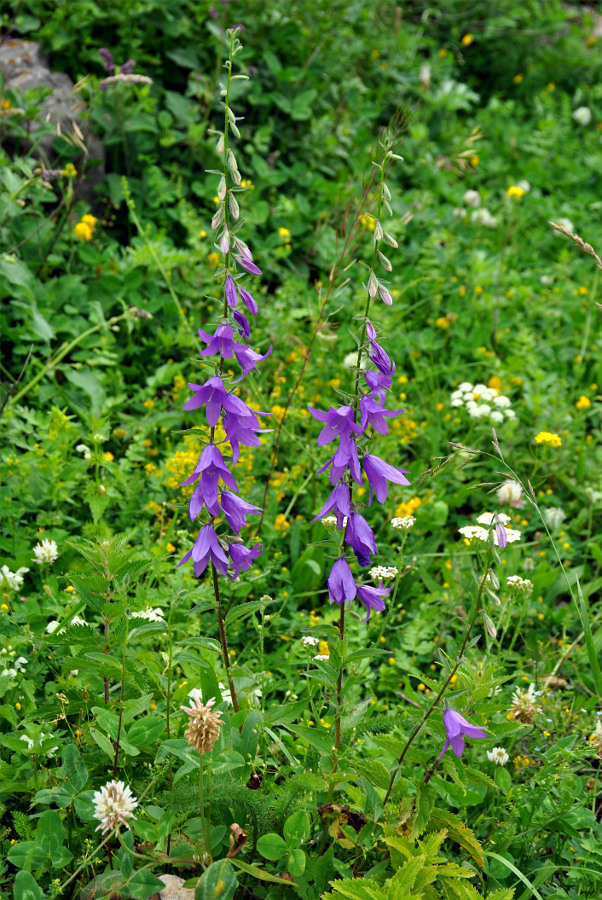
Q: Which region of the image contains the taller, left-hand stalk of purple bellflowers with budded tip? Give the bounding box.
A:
[178,28,272,712]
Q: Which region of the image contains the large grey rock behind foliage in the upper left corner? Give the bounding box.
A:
[0,38,105,199]
